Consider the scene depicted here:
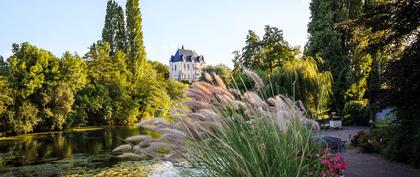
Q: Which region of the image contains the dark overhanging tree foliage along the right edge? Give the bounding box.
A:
[350,0,420,164]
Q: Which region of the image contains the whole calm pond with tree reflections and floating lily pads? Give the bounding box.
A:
[0,127,192,176]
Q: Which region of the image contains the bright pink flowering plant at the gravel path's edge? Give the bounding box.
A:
[321,153,347,177]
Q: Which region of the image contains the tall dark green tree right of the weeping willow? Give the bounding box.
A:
[305,0,363,112]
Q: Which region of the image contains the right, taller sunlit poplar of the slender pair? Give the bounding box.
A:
[126,0,146,76]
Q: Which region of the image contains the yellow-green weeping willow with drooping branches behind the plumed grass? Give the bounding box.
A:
[235,58,331,116]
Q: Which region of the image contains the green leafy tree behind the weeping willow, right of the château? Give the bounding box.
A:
[233,25,299,73]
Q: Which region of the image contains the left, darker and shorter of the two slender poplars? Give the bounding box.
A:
[102,0,127,55]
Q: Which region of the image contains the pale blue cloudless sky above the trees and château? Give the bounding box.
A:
[0,0,310,67]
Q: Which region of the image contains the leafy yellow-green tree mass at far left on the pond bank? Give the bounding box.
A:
[1,43,86,133]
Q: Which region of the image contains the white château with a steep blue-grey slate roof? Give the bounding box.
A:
[169,46,206,82]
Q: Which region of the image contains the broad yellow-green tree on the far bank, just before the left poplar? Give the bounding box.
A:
[71,41,139,125]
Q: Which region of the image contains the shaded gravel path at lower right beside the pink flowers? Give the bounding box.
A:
[321,127,420,177]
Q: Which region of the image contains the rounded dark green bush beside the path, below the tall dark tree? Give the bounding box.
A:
[343,100,369,126]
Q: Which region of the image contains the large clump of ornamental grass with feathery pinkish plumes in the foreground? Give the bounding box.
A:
[115,70,323,177]
